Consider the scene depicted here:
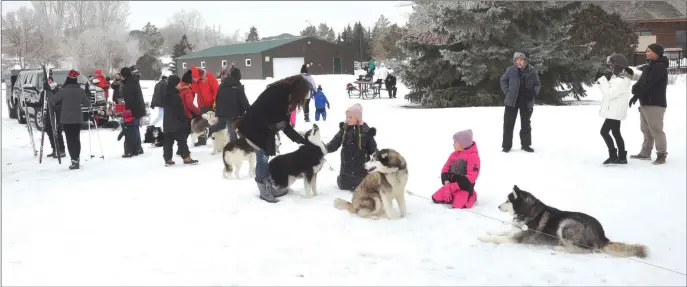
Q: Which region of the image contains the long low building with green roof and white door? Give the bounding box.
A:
[175,37,353,79]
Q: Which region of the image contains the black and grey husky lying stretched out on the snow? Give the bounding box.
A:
[479,185,648,258]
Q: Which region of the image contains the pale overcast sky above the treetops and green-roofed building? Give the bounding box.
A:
[2,1,411,37]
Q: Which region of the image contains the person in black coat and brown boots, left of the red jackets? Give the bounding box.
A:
[162,75,198,165]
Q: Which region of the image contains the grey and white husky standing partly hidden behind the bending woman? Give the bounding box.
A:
[222,133,281,179]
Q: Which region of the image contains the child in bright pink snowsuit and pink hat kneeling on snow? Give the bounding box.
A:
[432,130,480,208]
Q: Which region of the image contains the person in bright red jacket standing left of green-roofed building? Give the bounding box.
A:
[187,66,219,146]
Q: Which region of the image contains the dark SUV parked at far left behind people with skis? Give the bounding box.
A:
[7,69,107,131]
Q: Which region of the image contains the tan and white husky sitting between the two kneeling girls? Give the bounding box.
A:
[334,149,408,220]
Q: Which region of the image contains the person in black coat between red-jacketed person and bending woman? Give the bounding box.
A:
[208,68,250,141]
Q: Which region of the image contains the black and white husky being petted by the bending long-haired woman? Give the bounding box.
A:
[269,124,327,197]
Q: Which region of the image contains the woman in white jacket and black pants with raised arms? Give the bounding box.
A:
[597,54,634,164]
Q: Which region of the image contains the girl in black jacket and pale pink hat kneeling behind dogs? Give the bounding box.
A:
[327,104,377,191]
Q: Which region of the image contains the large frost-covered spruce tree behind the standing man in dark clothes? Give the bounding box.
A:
[400,1,590,107]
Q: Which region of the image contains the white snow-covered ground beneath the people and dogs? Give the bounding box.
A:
[2,75,687,286]
